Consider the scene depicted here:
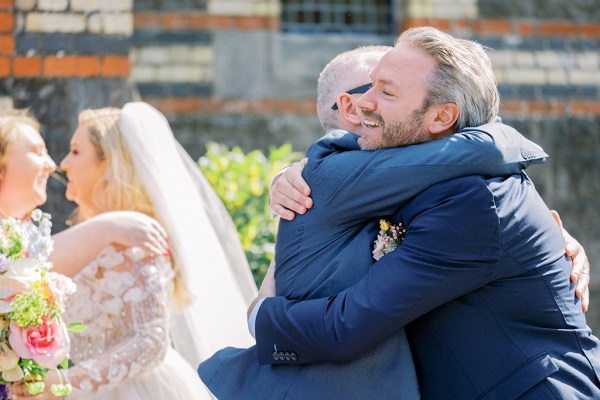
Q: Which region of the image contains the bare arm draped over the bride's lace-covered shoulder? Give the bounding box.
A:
[49,211,168,276]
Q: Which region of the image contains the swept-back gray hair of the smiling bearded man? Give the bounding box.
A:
[396,27,500,131]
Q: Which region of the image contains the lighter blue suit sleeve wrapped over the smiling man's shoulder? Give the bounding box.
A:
[303,122,547,225]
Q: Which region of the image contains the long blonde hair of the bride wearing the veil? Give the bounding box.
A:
[75,107,190,306]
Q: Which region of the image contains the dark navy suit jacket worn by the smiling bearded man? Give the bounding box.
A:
[256,154,600,400]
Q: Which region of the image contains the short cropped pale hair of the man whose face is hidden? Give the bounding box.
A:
[317,46,392,132]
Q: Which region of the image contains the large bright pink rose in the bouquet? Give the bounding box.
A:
[8,316,69,369]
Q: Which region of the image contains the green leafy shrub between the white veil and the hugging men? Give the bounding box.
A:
[198,143,303,286]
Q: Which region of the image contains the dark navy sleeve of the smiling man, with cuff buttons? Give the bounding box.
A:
[256,176,500,363]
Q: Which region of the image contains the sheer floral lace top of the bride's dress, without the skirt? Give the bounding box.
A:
[64,247,173,395]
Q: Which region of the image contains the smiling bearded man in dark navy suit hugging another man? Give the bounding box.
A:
[254,28,600,399]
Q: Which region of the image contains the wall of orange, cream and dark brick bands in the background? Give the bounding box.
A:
[0,0,600,330]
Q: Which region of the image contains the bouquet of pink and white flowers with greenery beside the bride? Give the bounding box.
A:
[0,210,77,397]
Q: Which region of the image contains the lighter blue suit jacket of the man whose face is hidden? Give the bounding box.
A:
[198,123,546,399]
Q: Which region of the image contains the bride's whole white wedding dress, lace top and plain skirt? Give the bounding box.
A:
[63,246,212,400]
